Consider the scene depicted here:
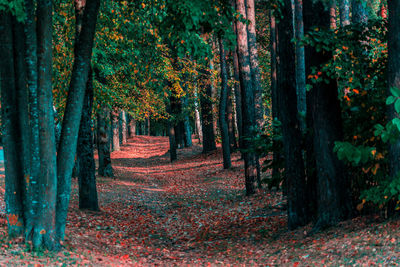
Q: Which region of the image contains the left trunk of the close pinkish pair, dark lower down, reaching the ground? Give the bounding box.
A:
[236,0,257,195]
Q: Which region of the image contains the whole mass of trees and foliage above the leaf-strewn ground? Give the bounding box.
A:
[0,0,400,264]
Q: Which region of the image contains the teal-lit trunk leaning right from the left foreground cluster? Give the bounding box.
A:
[55,0,100,240]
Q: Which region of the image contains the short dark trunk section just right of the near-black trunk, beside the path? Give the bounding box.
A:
[97,108,114,177]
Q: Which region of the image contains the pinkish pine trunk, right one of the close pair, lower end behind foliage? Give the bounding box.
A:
[246,0,264,131]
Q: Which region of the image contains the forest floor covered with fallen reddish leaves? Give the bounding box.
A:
[0,136,400,266]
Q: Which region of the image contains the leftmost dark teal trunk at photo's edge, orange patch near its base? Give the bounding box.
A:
[0,11,24,237]
